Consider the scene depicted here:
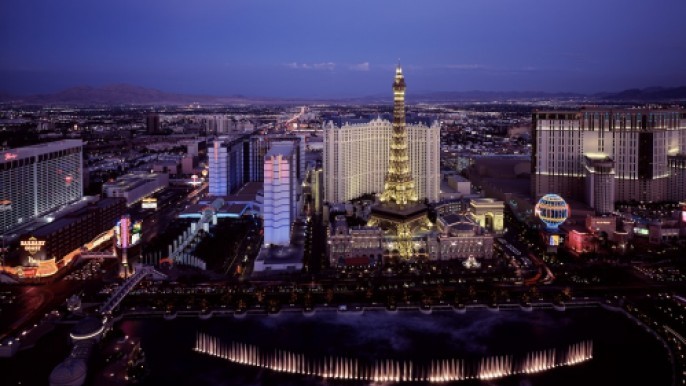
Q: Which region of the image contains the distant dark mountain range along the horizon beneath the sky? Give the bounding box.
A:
[0,84,686,105]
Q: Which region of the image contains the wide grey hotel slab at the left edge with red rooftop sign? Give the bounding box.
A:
[0,139,83,233]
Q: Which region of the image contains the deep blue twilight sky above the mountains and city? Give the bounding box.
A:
[0,0,686,98]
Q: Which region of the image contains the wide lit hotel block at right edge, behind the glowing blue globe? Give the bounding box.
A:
[532,108,686,213]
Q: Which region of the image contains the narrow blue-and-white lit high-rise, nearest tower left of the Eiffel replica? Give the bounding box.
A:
[263,142,298,246]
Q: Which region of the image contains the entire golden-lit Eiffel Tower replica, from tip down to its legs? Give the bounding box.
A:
[367,65,430,260]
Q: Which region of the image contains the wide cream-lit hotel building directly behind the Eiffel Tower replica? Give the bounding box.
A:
[323,118,441,203]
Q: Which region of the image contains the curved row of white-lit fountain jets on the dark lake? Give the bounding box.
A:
[194,333,593,382]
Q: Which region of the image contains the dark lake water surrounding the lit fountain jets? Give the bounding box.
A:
[119,308,672,386]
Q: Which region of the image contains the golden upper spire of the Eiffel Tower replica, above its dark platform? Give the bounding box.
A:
[381,65,417,206]
